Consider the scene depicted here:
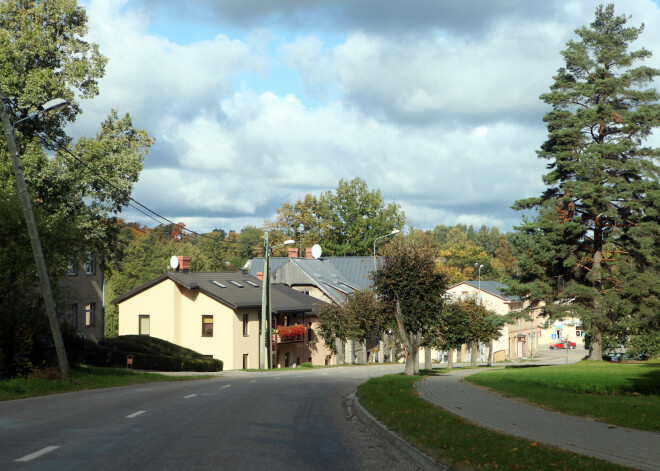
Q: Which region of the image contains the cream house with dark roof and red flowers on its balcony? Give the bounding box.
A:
[112,262,320,370]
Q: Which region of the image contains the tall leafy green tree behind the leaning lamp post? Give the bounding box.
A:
[0,0,153,370]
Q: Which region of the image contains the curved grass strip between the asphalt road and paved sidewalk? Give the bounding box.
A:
[357,370,626,470]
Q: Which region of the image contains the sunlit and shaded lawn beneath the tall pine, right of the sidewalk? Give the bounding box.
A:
[465,361,660,432]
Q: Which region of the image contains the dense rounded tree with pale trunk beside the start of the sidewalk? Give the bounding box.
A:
[373,237,447,376]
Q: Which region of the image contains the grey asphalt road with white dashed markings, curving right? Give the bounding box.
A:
[0,365,416,471]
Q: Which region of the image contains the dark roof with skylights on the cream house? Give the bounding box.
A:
[111,271,319,312]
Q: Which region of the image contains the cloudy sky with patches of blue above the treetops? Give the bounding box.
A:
[69,0,660,236]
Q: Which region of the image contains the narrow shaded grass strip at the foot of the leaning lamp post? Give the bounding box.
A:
[0,365,214,401]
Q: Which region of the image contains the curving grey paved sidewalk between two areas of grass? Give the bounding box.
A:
[416,369,660,470]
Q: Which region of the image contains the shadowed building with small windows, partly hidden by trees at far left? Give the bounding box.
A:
[58,252,105,342]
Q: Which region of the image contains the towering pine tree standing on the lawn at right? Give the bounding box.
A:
[510,5,660,360]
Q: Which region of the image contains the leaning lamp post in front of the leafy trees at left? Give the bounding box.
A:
[0,91,71,379]
